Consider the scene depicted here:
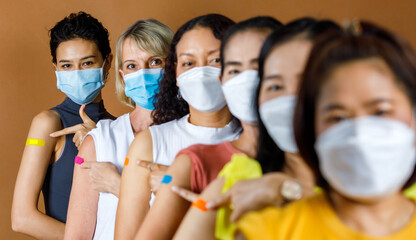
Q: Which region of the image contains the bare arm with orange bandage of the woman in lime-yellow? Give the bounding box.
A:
[173,178,224,240]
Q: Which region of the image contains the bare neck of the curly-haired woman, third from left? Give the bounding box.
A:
[188,106,233,128]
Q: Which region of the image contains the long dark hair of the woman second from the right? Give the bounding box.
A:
[256,18,340,173]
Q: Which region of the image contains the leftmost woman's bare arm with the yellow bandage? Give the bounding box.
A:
[11,110,65,239]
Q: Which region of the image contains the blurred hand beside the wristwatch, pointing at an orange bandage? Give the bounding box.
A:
[207,173,292,222]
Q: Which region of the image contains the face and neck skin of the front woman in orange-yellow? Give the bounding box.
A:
[315,58,415,237]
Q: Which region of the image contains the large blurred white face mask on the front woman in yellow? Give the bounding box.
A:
[315,117,416,199]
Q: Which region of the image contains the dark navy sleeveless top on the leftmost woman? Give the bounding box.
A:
[42,98,115,223]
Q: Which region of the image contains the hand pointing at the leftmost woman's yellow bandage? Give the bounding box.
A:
[49,104,97,148]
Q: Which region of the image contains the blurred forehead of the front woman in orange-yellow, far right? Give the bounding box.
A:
[319,58,406,103]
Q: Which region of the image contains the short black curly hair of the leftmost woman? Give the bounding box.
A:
[49,12,111,63]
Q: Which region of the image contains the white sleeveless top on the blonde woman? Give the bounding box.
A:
[88,113,134,240]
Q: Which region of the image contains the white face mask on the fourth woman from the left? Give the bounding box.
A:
[222,70,260,124]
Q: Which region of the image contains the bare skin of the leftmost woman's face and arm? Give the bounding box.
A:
[11,38,111,239]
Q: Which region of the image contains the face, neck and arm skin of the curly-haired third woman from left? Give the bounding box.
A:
[115,27,232,239]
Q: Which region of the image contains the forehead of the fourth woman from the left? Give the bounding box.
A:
[224,30,270,61]
